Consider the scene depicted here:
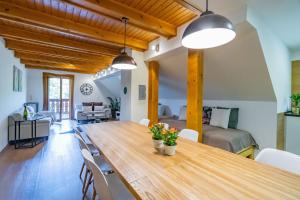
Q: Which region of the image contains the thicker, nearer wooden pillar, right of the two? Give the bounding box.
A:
[186,50,203,142]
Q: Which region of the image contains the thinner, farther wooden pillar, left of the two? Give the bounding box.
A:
[148,61,159,124]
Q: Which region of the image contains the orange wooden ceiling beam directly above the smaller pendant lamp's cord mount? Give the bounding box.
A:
[63,0,177,38]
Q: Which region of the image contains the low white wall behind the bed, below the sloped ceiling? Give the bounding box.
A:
[159,99,277,149]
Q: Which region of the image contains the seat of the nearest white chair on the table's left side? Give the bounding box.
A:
[105,173,135,200]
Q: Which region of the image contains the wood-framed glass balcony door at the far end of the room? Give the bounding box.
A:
[43,73,74,121]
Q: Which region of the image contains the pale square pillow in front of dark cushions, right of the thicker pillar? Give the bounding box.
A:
[209,108,231,129]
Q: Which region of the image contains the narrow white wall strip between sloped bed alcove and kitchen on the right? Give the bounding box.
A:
[247,7,291,113]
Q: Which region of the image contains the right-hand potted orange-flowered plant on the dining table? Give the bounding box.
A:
[163,128,178,156]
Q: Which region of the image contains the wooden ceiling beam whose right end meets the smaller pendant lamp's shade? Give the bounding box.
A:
[0,25,120,56]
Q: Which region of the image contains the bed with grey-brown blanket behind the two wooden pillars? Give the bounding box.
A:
[160,117,258,159]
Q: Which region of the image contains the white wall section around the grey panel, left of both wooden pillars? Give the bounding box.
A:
[120,50,148,122]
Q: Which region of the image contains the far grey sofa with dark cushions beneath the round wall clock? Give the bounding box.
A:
[74,102,111,122]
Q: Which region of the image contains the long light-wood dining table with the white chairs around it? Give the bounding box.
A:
[74,120,300,200]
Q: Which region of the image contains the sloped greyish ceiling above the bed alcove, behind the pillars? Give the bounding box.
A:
[158,22,276,101]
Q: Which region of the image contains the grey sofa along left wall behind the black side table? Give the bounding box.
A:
[8,108,52,143]
